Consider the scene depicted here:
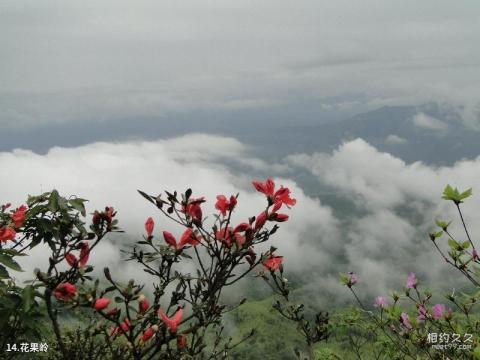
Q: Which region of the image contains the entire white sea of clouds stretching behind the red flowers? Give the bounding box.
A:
[0,134,480,306]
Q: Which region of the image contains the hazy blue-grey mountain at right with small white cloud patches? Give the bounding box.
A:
[264,104,480,165]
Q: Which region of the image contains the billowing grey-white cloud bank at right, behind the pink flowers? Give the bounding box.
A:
[288,139,480,293]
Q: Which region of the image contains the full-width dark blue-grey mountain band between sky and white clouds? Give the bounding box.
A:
[0,103,480,165]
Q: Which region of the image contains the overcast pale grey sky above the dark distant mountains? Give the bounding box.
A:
[0,0,480,129]
